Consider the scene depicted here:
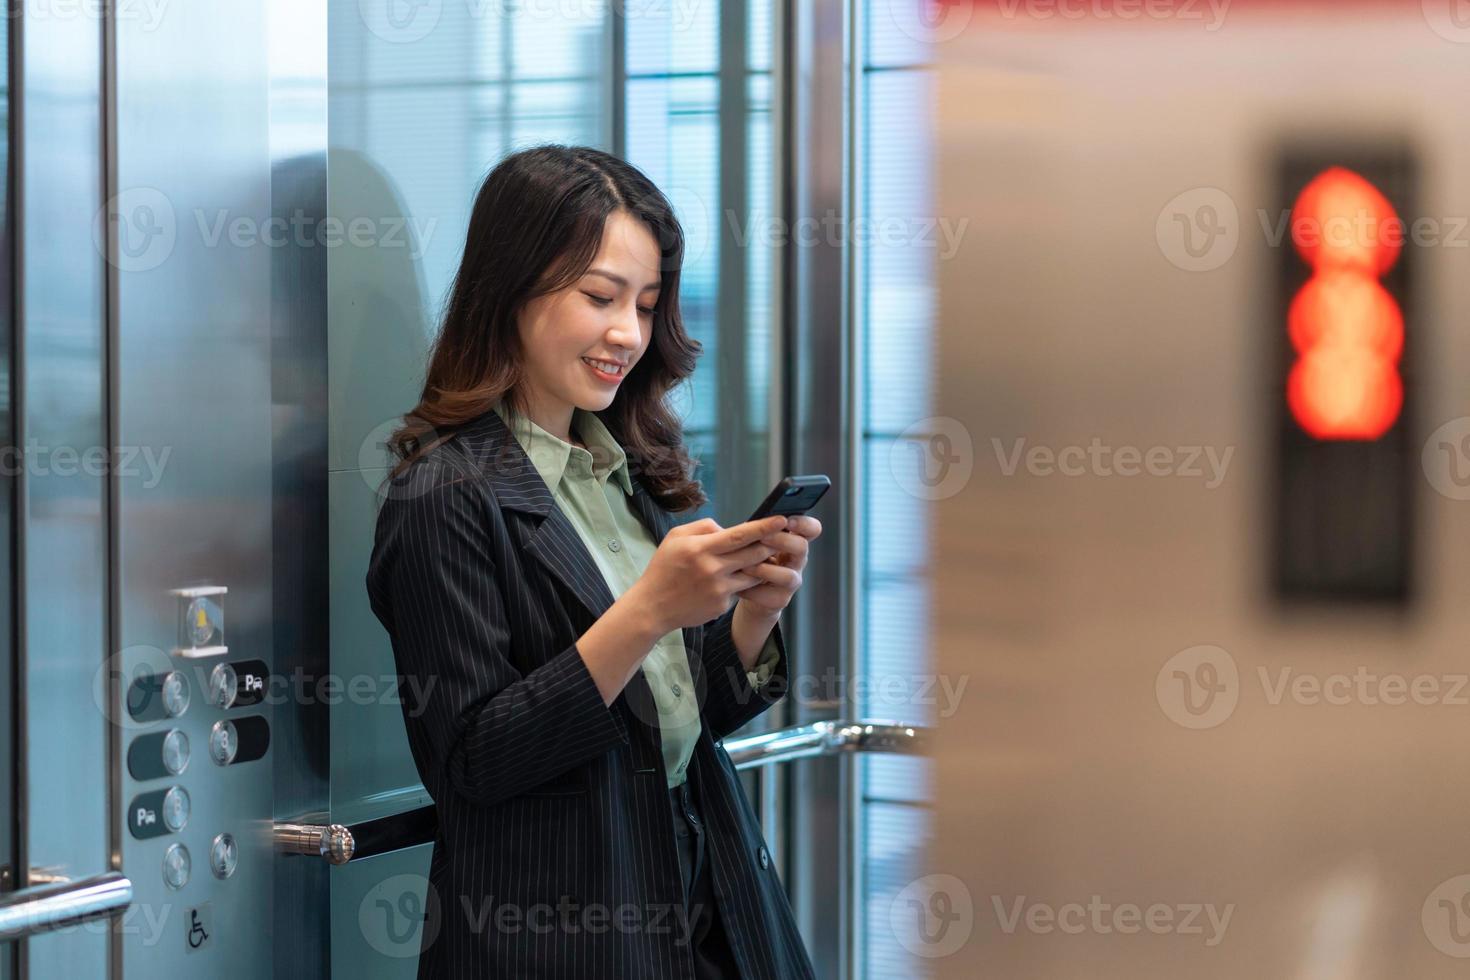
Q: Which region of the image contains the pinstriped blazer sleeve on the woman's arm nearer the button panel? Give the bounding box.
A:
[373,479,628,805]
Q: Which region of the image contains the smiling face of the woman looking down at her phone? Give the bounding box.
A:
[519,210,660,435]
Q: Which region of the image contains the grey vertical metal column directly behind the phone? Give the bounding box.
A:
[782,0,857,977]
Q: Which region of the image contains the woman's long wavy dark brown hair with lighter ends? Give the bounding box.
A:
[385,144,707,511]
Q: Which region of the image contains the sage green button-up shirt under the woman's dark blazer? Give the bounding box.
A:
[495,404,781,788]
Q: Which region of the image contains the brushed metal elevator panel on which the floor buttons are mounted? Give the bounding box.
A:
[109,3,277,980]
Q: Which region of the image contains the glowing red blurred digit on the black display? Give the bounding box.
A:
[1286,167,1404,439]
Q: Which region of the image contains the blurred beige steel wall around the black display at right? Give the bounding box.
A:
[926,3,1470,980]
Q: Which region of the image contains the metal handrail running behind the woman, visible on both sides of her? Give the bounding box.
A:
[275,721,929,864]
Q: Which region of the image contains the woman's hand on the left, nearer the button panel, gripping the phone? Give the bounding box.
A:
[634,514,786,635]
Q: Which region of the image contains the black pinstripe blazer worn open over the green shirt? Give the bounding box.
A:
[368,411,814,980]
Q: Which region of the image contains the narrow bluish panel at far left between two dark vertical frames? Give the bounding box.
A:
[16,7,108,980]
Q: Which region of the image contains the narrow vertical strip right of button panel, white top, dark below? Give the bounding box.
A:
[269,0,331,977]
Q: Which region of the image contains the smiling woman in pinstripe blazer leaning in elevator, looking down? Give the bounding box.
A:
[368,145,822,980]
